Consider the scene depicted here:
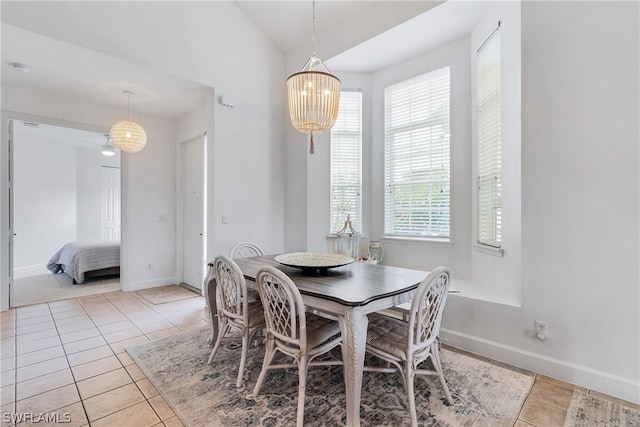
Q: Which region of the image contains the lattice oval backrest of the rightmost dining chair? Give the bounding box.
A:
[408,267,451,351]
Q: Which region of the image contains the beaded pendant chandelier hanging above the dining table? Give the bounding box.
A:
[287,0,340,154]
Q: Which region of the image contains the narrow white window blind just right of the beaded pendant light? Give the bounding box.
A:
[330,91,362,233]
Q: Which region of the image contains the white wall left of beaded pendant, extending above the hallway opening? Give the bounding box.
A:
[38,2,285,257]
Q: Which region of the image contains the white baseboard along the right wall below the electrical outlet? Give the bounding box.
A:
[440,328,640,403]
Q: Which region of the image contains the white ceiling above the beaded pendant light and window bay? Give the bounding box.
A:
[236,0,491,72]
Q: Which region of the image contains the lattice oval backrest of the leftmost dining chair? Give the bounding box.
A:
[213,255,249,325]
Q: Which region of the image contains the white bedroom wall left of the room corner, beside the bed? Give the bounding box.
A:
[13,127,77,277]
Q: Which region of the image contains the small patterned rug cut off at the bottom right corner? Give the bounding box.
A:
[564,390,640,427]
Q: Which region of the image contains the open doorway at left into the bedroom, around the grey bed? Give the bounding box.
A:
[9,119,120,307]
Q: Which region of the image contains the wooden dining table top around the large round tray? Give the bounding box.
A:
[234,255,429,306]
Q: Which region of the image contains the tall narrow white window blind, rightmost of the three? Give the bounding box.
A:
[477,30,502,248]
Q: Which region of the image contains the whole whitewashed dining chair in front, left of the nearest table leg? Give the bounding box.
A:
[253,266,343,426]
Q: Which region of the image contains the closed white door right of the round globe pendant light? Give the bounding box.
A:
[180,137,205,290]
